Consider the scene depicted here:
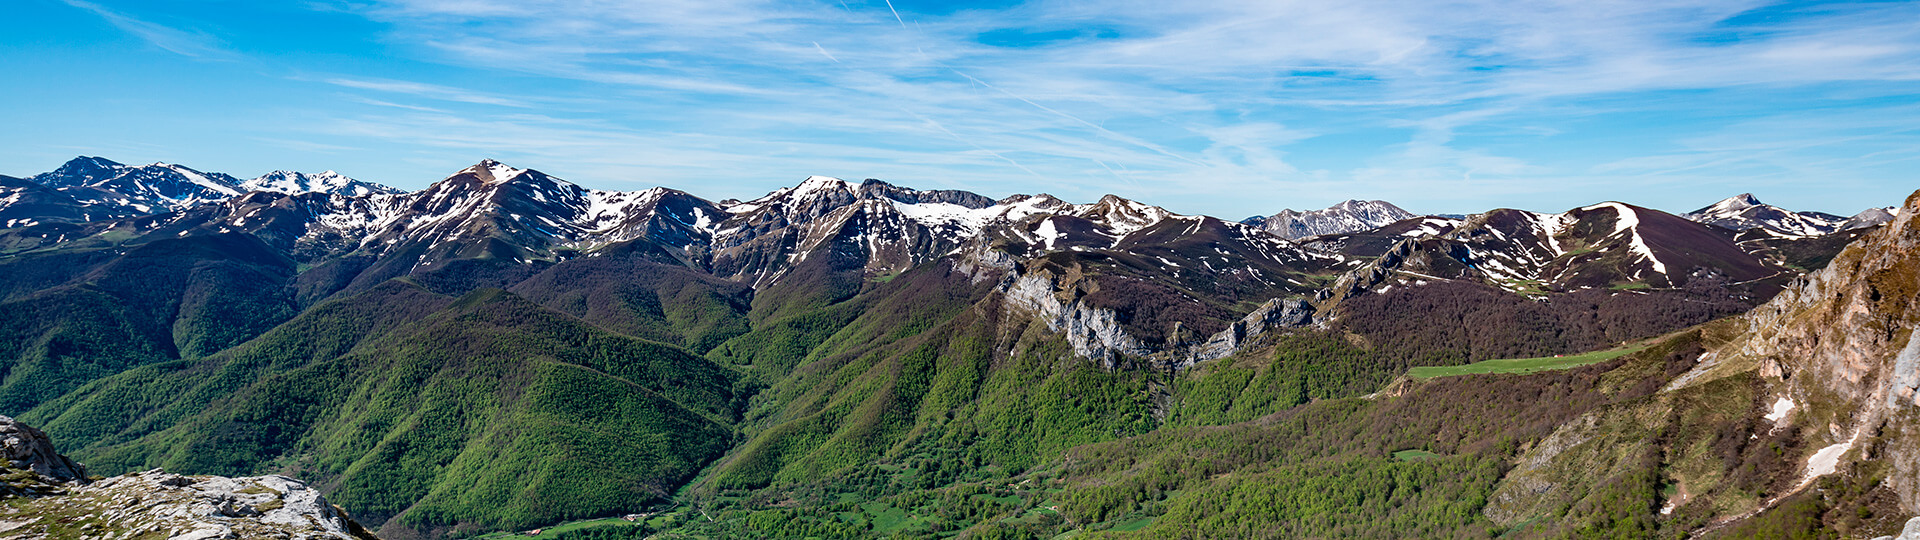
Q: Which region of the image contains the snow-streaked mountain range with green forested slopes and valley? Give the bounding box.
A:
[0,158,1920,538]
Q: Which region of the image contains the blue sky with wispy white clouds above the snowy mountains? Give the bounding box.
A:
[0,0,1920,219]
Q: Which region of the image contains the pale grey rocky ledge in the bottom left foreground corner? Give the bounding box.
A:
[0,417,374,540]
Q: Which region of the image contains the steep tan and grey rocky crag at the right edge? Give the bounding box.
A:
[1695,192,1920,513]
